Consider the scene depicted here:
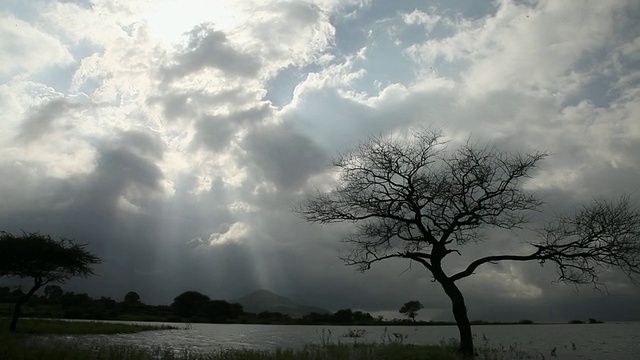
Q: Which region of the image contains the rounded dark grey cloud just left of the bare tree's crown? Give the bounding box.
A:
[242,125,329,190]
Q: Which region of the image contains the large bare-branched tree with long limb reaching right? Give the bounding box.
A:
[294,130,640,355]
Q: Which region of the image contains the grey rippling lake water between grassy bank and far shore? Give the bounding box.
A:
[56,322,640,360]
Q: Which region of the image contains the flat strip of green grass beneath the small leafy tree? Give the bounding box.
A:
[0,318,175,334]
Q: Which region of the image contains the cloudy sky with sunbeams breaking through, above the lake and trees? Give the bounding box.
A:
[0,0,640,321]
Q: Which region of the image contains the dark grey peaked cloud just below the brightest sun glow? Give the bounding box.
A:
[163,24,260,81]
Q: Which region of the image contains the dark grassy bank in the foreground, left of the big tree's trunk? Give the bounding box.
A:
[0,319,458,360]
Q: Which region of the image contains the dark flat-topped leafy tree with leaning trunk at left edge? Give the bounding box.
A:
[0,231,100,332]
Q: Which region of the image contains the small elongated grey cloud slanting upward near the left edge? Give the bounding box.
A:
[16,98,83,142]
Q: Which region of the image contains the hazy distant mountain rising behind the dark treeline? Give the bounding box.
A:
[230,290,329,318]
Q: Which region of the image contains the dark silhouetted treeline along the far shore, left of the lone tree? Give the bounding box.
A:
[0,285,383,325]
